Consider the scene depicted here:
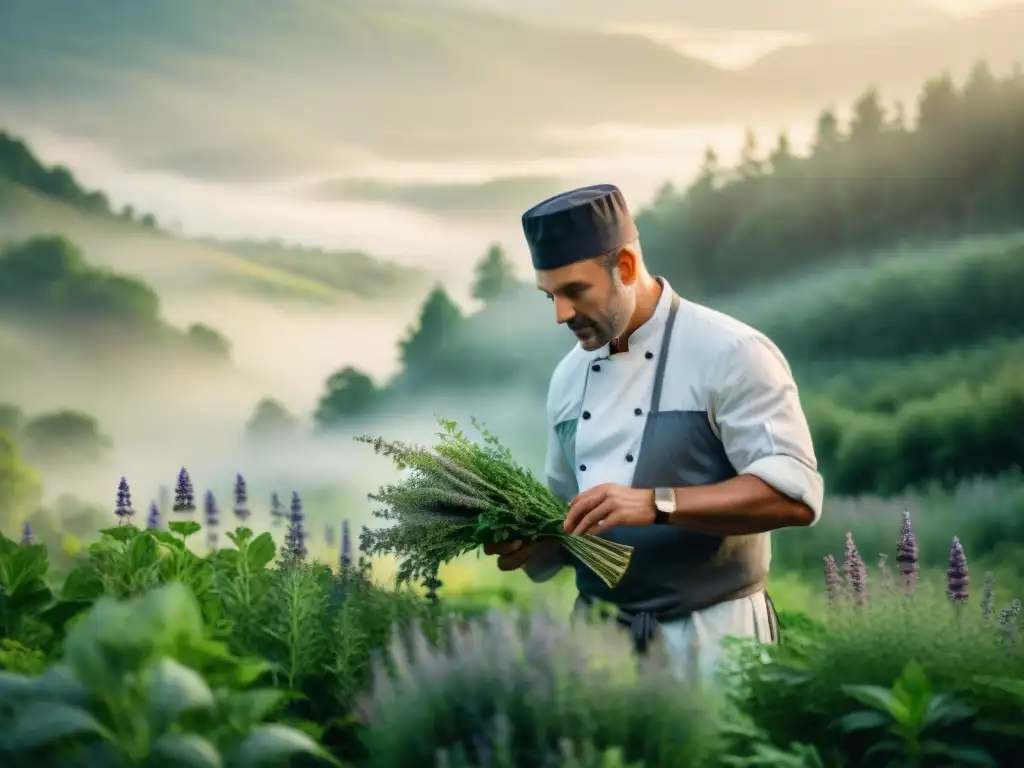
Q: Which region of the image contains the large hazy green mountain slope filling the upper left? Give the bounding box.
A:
[0,0,778,178]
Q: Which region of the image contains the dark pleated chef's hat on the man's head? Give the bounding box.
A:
[522,184,639,270]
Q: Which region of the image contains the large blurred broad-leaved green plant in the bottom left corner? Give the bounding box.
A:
[0,583,335,768]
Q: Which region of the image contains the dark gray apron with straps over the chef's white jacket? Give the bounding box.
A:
[555,284,779,652]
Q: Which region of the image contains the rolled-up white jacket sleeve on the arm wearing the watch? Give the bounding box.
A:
[710,334,824,525]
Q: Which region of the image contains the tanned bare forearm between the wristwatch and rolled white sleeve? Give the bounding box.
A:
[669,474,814,536]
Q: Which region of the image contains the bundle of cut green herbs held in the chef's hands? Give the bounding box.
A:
[355,419,633,587]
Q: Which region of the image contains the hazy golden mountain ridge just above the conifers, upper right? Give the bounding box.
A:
[745,3,1024,101]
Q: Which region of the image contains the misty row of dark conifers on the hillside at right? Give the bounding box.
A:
[638,62,1024,295]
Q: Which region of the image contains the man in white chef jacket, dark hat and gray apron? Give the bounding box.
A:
[486,184,823,679]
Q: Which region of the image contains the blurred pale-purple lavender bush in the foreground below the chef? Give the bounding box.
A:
[359,612,722,768]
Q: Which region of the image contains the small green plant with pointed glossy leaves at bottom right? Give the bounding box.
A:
[837,662,997,768]
